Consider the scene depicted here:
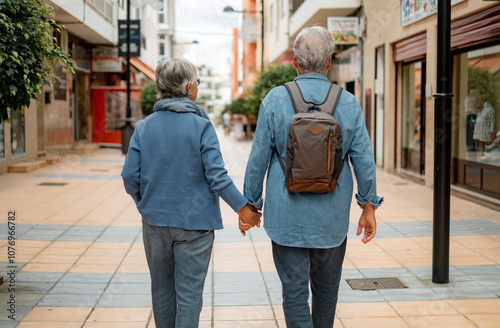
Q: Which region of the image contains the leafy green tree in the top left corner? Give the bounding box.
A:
[0,0,75,122]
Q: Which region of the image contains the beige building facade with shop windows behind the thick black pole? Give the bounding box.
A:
[363,0,500,202]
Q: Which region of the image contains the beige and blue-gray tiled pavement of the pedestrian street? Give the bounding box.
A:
[0,129,500,328]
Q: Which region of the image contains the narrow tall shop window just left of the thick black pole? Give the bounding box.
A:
[401,61,425,175]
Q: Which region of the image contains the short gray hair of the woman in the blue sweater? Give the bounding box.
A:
[155,58,198,99]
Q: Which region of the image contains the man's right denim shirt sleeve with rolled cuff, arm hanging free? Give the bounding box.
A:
[348,110,384,208]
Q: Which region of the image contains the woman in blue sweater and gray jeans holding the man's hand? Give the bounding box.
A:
[122,59,260,328]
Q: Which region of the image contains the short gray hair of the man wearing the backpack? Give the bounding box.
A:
[293,26,335,73]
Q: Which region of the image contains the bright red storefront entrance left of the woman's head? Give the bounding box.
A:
[92,87,143,146]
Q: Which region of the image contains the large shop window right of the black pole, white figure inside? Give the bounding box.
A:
[452,46,500,198]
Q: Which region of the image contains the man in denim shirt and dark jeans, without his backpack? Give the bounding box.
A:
[244,26,383,328]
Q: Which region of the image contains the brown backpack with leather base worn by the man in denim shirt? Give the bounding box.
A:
[275,82,344,193]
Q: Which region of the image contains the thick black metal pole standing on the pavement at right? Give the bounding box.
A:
[432,0,453,284]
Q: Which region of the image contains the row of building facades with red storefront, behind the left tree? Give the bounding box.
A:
[0,0,174,174]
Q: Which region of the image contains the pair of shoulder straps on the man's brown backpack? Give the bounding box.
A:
[284,81,342,115]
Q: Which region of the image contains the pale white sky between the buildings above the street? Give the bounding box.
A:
[175,0,242,74]
